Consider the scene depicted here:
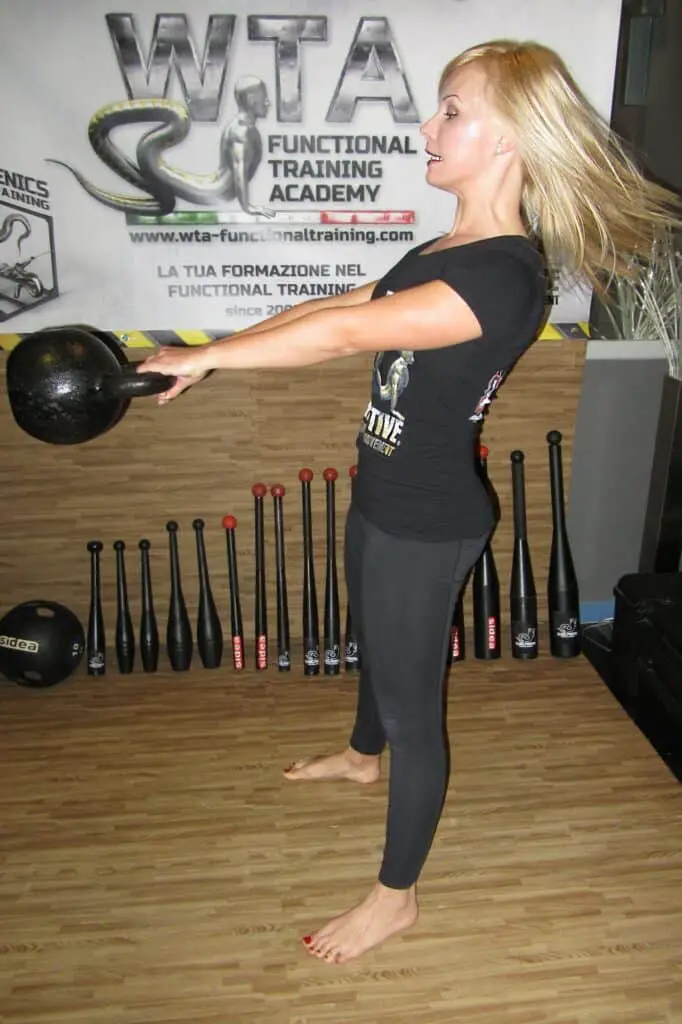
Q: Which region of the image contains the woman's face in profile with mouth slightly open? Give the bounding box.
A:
[421,63,505,193]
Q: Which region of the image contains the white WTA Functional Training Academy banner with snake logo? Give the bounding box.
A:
[0,0,621,341]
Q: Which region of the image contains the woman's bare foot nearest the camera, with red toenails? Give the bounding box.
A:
[303,882,419,964]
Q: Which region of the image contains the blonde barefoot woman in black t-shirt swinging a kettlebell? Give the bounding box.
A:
[139,41,674,963]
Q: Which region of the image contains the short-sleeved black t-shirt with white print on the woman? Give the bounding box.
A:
[353,236,547,541]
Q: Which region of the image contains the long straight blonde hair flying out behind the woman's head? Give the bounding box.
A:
[439,39,680,293]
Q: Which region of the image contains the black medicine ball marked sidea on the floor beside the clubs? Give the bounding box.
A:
[0,601,85,687]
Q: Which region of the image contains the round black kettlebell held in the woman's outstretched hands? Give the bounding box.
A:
[5,325,175,444]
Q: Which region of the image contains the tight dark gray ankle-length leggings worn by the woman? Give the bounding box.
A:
[344,505,488,889]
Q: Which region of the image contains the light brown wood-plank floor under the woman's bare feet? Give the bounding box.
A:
[0,656,682,1024]
